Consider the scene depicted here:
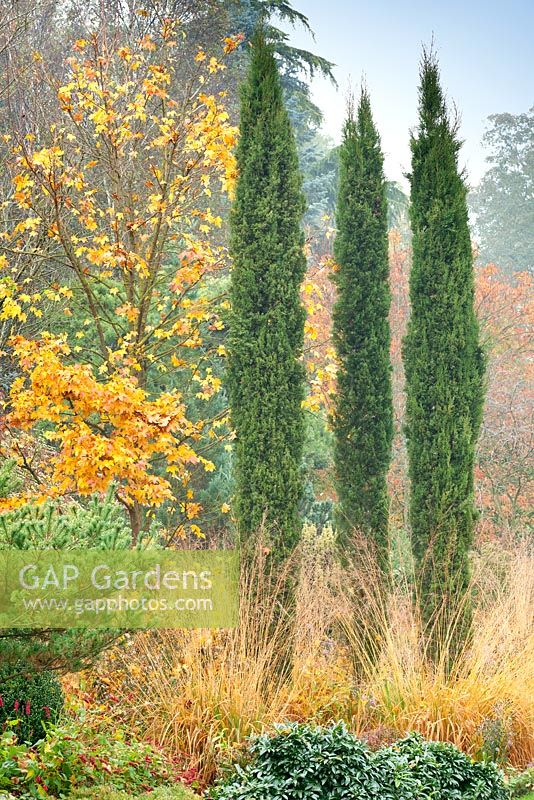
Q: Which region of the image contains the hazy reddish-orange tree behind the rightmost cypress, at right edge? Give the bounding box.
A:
[476,264,534,546]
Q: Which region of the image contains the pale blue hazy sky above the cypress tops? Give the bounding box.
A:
[282,0,534,185]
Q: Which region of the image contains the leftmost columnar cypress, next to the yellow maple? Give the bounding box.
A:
[227,32,306,558]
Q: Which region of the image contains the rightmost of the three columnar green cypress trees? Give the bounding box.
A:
[404,53,484,655]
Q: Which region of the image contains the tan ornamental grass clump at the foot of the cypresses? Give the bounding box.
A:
[80,531,534,782]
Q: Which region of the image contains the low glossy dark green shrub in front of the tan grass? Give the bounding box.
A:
[211,723,509,800]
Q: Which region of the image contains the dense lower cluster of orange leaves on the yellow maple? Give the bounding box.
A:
[9,337,211,506]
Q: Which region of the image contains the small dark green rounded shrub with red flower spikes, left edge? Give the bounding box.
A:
[0,664,63,744]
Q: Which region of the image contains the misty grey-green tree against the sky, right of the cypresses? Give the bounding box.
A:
[470,106,534,272]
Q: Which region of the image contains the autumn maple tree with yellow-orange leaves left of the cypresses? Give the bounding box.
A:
[0,22,239,540]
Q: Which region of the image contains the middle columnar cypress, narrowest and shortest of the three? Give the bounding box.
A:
[334,91,393,571]
